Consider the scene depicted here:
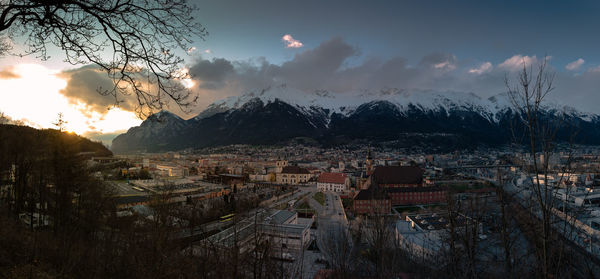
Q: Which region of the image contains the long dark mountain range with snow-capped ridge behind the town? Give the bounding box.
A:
[112,85,600,153]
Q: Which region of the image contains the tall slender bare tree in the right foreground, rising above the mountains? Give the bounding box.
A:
[505,57,596,278]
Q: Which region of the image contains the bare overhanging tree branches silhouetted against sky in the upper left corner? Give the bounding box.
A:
[0,0,208,116]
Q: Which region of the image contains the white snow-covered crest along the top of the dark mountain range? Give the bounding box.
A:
[195,85,510,119]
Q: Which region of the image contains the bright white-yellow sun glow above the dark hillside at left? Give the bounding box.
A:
[0,64,141,137]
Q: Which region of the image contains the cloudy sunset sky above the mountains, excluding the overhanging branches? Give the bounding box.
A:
[0,0,600,143]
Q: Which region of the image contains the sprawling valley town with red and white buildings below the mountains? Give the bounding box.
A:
[72,145,600,278]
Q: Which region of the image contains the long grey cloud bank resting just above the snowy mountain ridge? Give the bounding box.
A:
[182,37,600,117]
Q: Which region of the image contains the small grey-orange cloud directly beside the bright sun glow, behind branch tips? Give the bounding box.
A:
[60,66,137,114]
